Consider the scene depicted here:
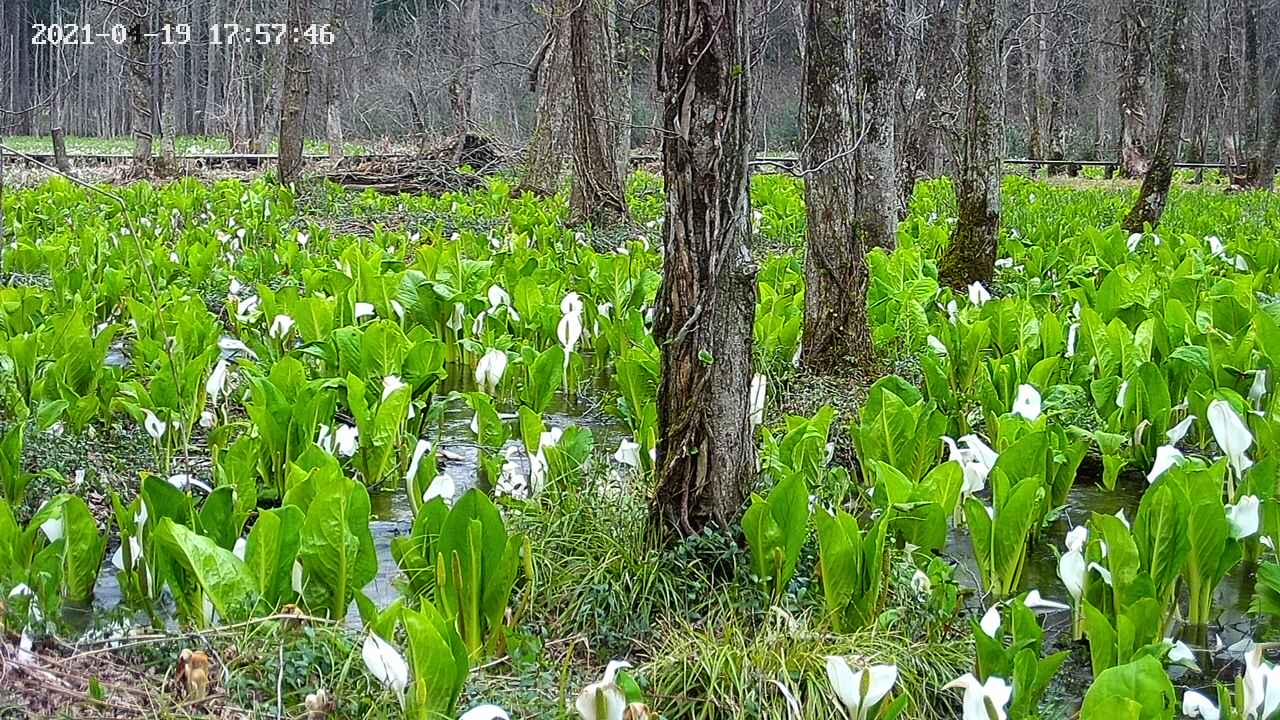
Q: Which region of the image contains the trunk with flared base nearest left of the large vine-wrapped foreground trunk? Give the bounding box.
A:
[568,0,627,224]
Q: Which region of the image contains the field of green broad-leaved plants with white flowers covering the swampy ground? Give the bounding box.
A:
[0,173,1280,720]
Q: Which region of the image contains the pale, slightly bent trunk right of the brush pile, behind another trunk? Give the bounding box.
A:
[520,0,573,195]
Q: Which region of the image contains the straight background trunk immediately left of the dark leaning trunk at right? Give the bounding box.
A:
[1119,0,1151,178]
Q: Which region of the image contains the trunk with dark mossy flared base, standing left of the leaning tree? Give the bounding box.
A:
[938,0,1004,288]
